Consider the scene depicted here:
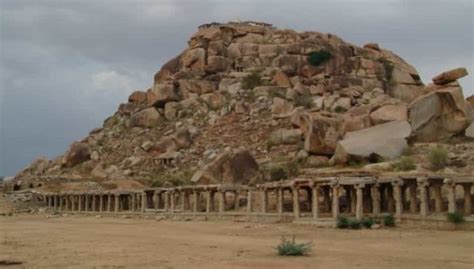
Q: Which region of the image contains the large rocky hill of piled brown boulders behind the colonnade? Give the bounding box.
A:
[12,22,474,191]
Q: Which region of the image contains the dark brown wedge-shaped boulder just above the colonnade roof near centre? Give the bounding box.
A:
[191,150,258,185]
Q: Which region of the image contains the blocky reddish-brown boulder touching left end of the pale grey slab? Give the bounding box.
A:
[304,114,343,155]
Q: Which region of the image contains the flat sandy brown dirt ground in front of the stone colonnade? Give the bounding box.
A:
[0,215,474,269]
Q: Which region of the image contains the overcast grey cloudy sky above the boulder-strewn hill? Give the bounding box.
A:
[0,0,474,175]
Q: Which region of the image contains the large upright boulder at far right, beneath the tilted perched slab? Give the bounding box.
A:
[408,87,469,142]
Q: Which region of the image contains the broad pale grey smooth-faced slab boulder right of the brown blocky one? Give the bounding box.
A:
[333,121,411,163]
